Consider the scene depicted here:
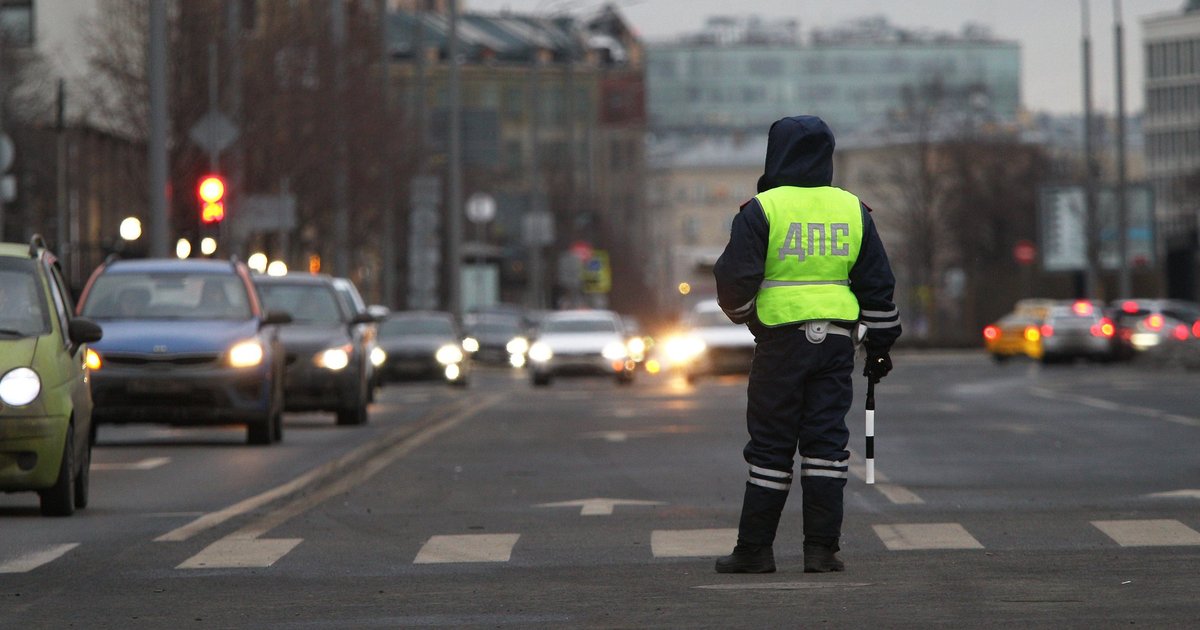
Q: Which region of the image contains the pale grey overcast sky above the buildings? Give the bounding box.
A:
[463,0,1186,113]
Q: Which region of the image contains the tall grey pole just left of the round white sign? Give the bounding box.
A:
[446,0,462,318]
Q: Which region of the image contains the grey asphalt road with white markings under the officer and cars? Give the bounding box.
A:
[0,353,1200,629]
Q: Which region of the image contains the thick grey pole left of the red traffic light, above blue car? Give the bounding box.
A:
[146,0,170,258]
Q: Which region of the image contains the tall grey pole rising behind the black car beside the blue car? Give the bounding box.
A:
[329,0,350,276]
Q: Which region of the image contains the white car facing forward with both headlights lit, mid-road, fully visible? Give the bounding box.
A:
[526,311,634,385]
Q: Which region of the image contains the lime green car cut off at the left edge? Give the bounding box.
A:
[0,236,101,516]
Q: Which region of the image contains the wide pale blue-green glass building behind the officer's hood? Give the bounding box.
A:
[646,38,1021,134]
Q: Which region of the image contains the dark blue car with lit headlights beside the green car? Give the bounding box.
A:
[79,259,289,444]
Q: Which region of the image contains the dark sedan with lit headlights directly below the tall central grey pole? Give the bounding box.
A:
[378,311,470,385]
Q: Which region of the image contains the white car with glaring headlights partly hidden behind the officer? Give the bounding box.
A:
[664,301,755,383]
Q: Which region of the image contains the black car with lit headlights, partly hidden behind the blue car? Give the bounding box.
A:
[254,274,374,425]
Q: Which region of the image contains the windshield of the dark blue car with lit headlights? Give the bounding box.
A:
[83,271,252,320]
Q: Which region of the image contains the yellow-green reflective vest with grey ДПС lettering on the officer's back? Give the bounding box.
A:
[755,186,863,326]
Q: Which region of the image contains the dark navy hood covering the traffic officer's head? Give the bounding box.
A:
[758,116,833,192]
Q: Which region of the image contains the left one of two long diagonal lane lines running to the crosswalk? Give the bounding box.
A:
[155,396,498,542]
